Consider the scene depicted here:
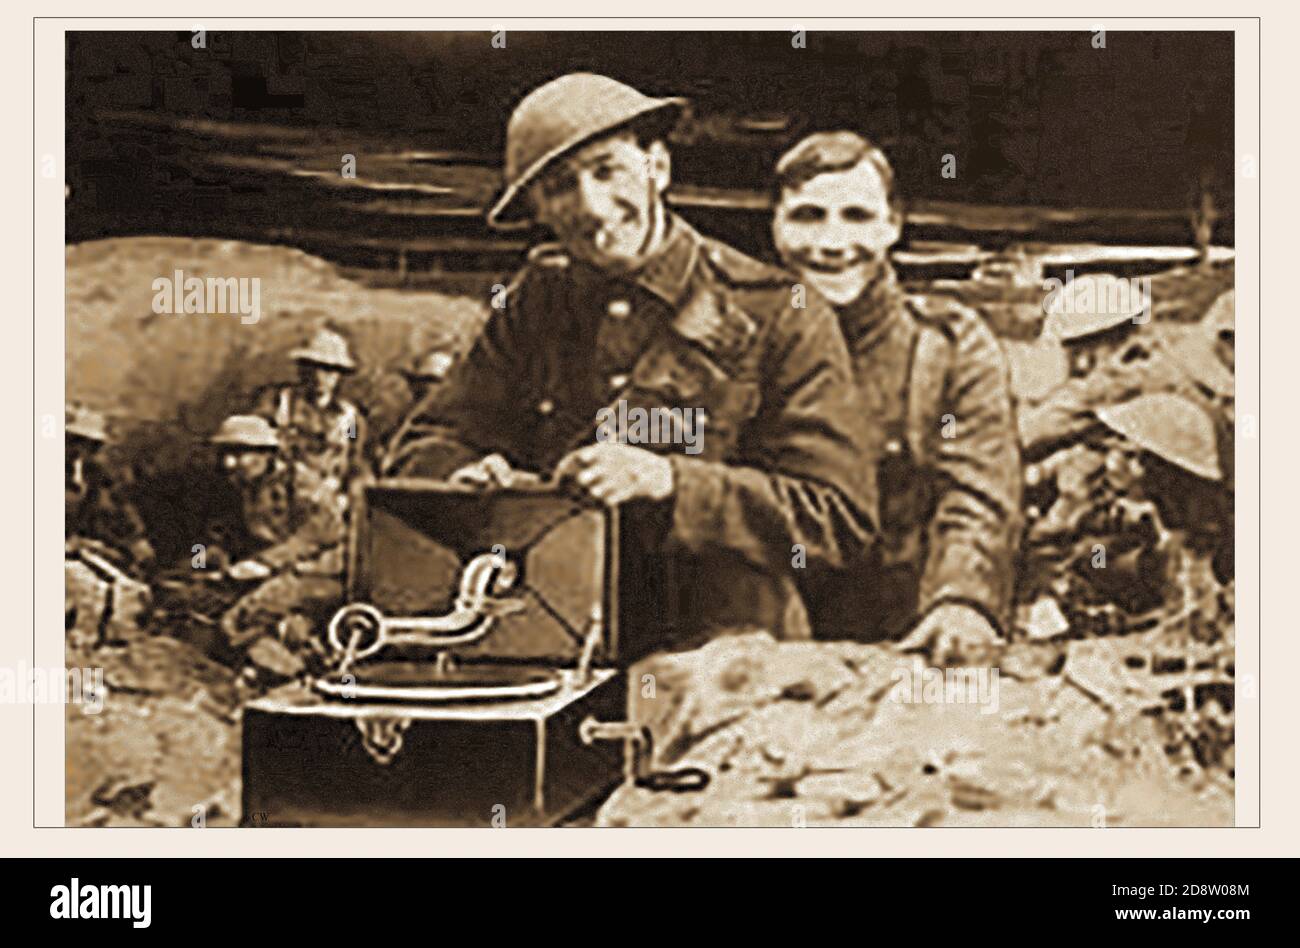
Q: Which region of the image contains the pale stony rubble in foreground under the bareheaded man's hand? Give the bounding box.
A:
[595,633,1234,826]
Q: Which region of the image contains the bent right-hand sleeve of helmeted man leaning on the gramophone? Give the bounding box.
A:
[671,299,876,571]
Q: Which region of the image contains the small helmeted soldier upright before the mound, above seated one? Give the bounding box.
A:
[254,329,365,509]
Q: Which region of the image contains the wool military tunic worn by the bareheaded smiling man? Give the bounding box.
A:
[809,269,1022,640]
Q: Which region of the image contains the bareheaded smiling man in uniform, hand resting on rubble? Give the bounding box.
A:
[772,131,1021,659]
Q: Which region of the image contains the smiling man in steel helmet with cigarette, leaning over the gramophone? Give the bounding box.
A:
[390,74,875,645]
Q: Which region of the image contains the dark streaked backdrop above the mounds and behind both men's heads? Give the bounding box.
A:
[66,30,1234,269]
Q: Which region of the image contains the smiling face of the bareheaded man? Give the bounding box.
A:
[772,161,901,304]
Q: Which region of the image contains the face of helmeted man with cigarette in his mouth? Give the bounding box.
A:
[532,133,670,269]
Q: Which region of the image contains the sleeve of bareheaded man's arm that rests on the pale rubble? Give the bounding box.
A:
[918,313,1022,631]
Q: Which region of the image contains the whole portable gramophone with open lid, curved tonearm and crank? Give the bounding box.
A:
[243,480,707,826]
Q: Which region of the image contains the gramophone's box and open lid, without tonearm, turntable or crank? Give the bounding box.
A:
[243,480,640,826]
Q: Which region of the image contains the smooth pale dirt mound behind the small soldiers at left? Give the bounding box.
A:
[65,237,488,434]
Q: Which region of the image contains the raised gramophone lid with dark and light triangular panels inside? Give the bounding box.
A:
[348,479,616,665]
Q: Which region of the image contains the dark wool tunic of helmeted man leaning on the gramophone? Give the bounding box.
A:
[403,217,875,645]
